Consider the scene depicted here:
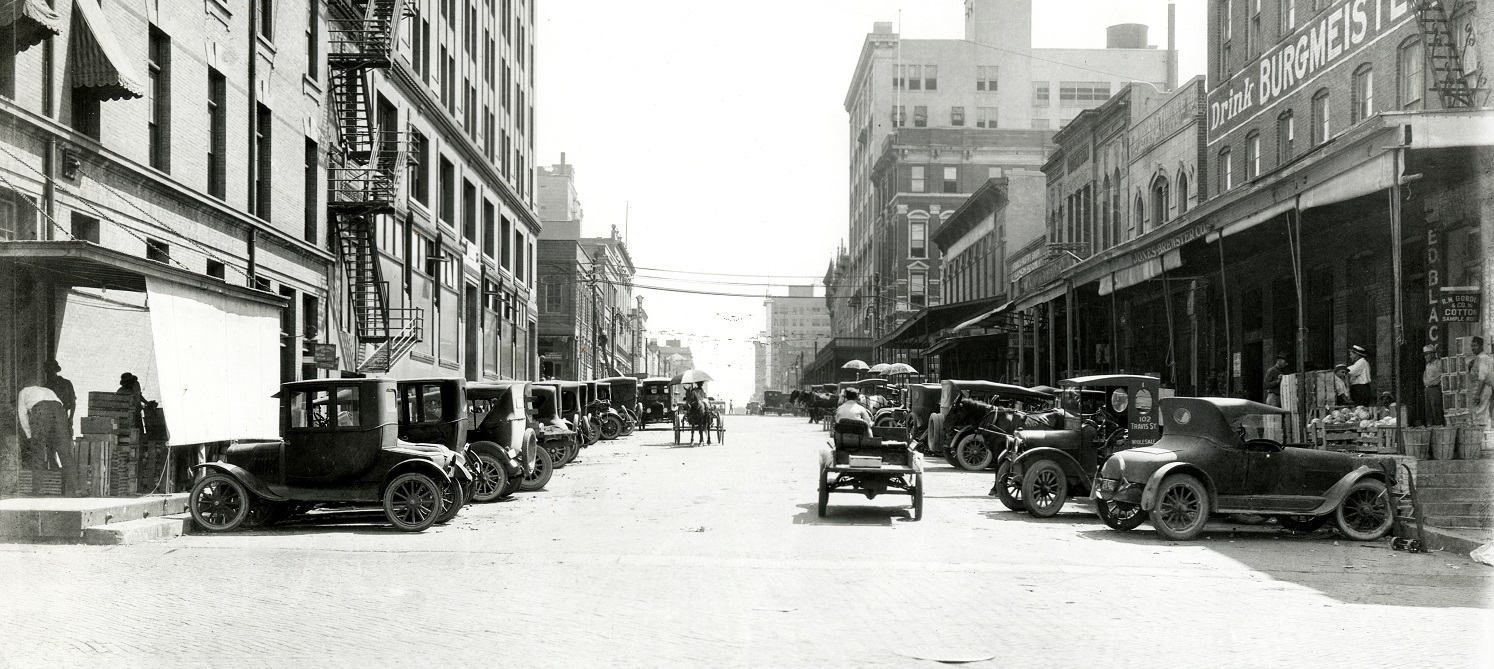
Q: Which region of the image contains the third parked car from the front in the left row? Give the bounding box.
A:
[466,381,554,502]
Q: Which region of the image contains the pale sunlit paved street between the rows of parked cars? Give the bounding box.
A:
[0,417,1494,668]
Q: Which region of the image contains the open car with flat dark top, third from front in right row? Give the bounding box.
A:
[931,379,1053,472]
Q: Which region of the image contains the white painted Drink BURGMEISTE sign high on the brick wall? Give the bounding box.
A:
[1209,0,1416,143]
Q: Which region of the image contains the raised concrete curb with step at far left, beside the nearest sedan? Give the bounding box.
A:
[0,493,187,544]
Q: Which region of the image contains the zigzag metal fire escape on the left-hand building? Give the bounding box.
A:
[327,0,423,372]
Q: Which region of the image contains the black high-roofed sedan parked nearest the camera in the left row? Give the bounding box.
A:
[188,378,472,532]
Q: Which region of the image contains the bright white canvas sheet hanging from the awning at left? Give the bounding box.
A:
[145,276,279,445]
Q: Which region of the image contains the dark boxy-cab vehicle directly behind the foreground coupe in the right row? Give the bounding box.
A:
[992,375,1164,518]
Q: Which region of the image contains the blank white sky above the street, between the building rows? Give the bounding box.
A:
[535,0,1206,406]
